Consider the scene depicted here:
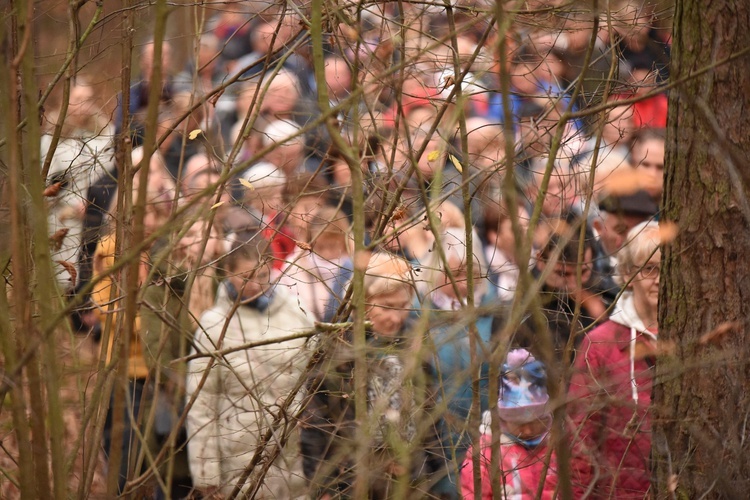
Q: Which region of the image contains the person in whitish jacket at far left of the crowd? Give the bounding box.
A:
[41,78,115,290]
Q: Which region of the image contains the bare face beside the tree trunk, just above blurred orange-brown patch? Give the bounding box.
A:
[630,128,666,202]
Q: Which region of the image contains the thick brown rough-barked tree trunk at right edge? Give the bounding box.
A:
[652,0,750,498]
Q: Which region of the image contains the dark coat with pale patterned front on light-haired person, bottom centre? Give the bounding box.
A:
[301,335,445,499]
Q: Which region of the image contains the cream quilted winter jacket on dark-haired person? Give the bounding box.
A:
[187,282,312,498]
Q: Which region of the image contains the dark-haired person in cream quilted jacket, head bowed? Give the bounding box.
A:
[186,233,312,498]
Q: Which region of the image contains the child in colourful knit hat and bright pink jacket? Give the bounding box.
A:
[461,349,557,500]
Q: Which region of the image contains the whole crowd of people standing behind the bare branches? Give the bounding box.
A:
[42,0,669,499]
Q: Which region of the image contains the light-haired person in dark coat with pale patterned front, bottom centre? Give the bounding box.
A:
[301,252,445,500]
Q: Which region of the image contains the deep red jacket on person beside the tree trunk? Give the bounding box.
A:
[570,313,655,500]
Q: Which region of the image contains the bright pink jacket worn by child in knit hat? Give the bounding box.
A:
[461,435,557,500]
